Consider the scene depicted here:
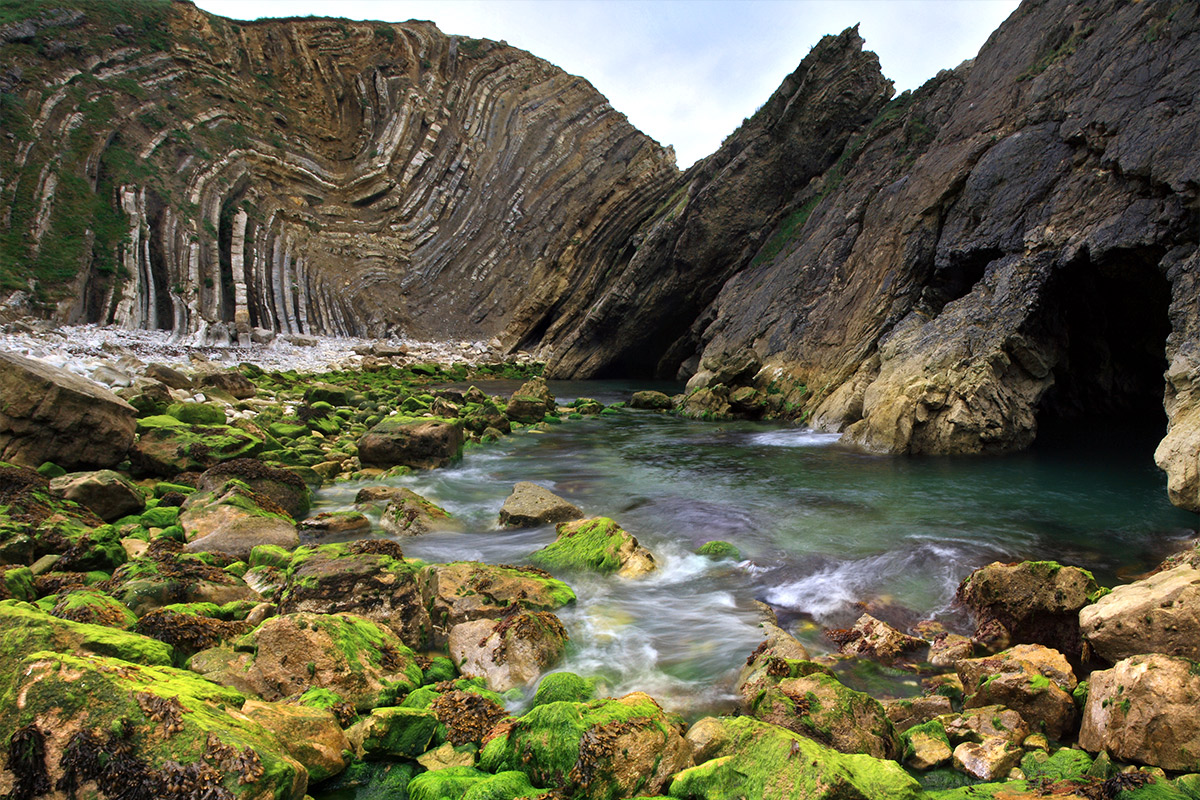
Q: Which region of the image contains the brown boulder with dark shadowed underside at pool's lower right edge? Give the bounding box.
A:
[958,561,1099,663]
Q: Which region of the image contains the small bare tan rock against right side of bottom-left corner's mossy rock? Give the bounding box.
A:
[241,700,350,783]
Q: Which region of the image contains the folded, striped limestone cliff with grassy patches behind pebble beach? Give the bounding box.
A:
[0,0,678,341]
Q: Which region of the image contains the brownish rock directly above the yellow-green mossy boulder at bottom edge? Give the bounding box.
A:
[743,661,900,759]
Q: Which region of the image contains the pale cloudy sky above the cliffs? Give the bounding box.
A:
[196,0,1018,167]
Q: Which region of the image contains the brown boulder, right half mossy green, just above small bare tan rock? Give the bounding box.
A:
[188,612,421,711]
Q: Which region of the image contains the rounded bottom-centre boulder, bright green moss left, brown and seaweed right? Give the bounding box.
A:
[479,692,691,800]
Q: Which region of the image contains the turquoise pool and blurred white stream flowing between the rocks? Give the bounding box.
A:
[314,383,1198,717]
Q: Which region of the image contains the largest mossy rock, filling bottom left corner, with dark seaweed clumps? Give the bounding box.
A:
[0,652,308,800]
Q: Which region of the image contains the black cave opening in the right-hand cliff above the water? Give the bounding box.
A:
[1038,248,1171,450]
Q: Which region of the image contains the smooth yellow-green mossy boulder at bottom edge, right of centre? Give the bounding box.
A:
[670,717,925,800]
